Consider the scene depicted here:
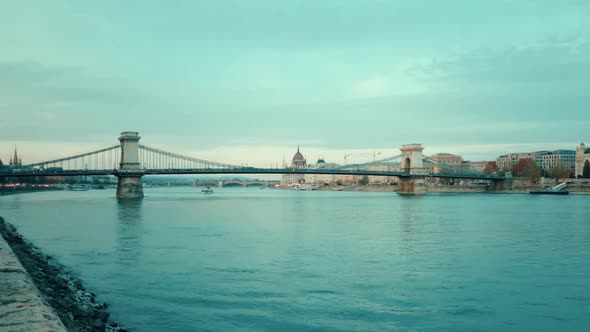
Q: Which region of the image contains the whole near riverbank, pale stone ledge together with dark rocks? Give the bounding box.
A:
[0,217,126,332]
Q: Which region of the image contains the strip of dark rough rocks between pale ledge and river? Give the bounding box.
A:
[0,217,128,332]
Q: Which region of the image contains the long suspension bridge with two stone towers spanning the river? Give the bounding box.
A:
[0,132,504,198]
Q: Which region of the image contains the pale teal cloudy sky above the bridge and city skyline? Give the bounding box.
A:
[0,0,590,166]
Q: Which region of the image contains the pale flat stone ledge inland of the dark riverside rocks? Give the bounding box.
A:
[0,235,67,332]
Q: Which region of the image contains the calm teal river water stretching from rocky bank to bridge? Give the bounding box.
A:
[0,188,590,331]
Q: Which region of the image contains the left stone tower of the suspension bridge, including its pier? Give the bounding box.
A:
[117,131,143,198]
